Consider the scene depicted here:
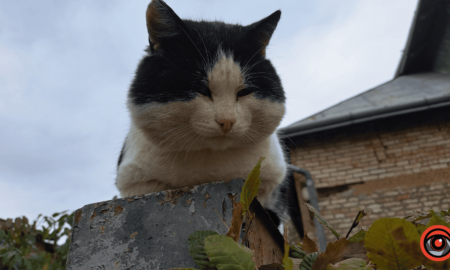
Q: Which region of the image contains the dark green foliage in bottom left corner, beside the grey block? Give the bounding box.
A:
[0,212,73,270]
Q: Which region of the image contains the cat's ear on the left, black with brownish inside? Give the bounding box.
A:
[146,0,184,51]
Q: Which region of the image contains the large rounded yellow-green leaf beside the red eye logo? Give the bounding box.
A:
[364,218,421,270]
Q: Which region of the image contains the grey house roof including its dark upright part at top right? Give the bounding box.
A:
[279,0,450,138]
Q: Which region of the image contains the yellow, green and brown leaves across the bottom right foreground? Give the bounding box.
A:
[173,155,450,270]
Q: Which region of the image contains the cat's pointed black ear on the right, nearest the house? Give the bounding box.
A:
[247,10,281,56]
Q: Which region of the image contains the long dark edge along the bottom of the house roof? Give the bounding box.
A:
[278,96,450,139]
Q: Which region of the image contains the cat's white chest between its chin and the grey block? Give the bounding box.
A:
[116,124,286,205]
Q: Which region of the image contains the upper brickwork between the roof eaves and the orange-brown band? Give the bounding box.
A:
[291,109,450,188]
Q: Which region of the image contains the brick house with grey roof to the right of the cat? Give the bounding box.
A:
[280,0,450,241]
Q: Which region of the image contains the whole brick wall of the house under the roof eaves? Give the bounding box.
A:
[287,108,450,243]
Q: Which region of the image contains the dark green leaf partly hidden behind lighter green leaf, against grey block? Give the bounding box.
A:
[188,231,217,269]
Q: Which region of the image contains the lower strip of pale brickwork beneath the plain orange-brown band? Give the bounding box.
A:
[319,175,450,241]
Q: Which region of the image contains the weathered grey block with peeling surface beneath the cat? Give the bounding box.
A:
[67,179,244,270]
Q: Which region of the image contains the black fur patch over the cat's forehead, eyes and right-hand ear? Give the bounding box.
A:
[129,1,285,105]
